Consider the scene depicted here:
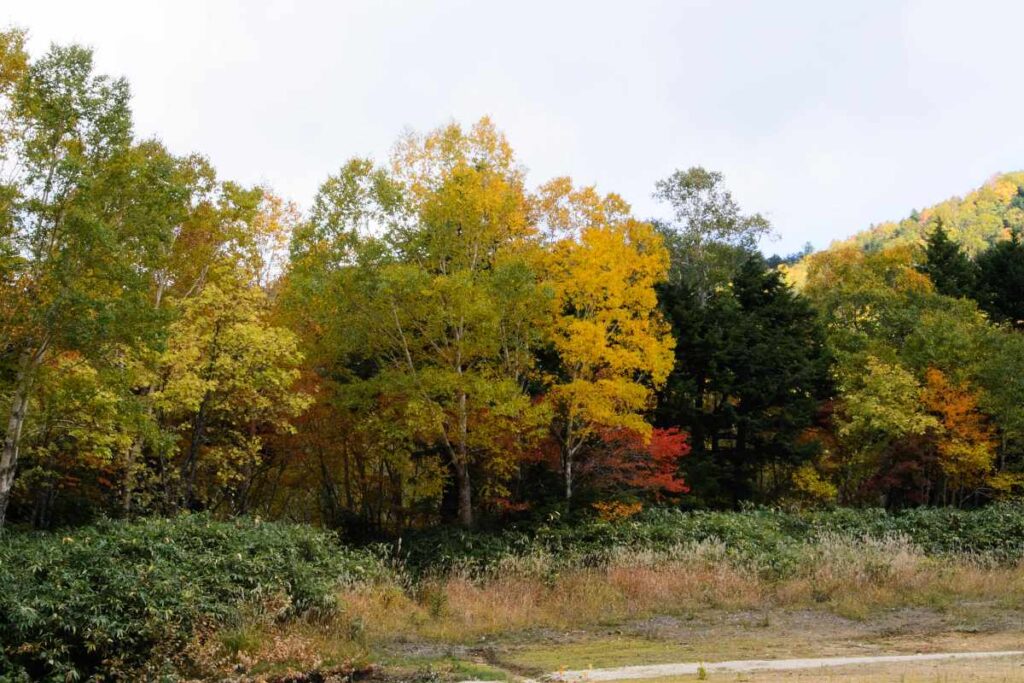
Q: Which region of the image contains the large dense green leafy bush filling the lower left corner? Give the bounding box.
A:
[0,515,380,681]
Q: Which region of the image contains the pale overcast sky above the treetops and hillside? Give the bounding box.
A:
[0,0,1024,253]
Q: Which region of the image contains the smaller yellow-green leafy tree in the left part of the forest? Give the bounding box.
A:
[154,275,309,508]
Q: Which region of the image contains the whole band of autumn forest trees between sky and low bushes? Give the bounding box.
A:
[0,30,1024,540]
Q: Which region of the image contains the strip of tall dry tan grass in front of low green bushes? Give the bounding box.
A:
[342,539,1024,642]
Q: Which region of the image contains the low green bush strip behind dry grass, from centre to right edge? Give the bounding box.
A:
[402,503,1024,578]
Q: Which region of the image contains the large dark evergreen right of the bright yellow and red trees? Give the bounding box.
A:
[658,254,828,505]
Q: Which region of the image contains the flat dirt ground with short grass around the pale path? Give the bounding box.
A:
[389,604,1024,682]
